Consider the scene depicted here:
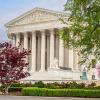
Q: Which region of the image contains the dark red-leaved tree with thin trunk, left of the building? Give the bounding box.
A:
[0,42,30,93]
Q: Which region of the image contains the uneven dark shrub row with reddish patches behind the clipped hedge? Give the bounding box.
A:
[5,81,100,89]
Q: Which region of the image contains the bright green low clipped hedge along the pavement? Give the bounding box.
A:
[22,87,100,98]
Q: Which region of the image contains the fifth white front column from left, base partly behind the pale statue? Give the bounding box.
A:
[50,30,54,68]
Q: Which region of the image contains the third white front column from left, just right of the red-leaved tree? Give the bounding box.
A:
[31,32,36,72]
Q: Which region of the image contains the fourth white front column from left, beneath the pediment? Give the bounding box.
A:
[40,30,45,71]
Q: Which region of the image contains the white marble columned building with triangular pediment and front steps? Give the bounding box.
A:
[6,7,81,81]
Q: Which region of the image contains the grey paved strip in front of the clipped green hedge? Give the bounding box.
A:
[0,96,100,100]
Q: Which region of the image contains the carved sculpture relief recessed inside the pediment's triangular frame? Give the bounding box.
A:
[11,11,58,25]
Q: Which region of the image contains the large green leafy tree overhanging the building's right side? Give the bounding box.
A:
[60,0,100,67]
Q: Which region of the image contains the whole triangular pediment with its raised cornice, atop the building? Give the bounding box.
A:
[6,8,68,26]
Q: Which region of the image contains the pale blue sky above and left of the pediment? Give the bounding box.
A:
[0,0,67,42]
